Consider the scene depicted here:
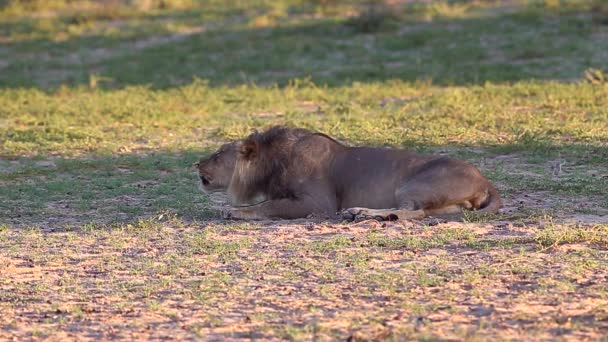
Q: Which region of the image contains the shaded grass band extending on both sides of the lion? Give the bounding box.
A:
[0,139,608,228]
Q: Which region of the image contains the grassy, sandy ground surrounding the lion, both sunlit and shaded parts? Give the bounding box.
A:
[0,0,608,340]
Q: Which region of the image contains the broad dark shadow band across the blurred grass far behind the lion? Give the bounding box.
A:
[0,4,608,90]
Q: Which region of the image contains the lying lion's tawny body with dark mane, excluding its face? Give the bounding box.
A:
[221,126,502,220]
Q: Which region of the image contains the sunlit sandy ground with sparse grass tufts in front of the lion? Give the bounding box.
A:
[0,220,608,340]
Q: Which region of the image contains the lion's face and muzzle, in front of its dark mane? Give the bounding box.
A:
[195,142,240,193]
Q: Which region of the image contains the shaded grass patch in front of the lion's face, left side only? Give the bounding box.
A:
[0,151,215,227]
